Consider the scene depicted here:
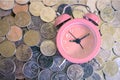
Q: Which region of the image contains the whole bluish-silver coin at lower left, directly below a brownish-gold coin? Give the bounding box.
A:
[23,61,39,79]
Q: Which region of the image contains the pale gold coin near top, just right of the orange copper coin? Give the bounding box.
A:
[29,1,45,16]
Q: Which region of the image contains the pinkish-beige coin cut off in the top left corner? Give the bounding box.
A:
[0,0,14,10]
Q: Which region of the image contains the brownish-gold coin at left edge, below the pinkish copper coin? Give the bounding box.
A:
[0,41,16,57]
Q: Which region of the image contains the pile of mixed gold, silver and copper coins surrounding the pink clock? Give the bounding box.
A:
[0,0,120,80]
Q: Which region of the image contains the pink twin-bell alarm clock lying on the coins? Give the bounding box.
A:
[55,4,101,63]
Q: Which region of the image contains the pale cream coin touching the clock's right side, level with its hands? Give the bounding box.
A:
[101,34,114,50]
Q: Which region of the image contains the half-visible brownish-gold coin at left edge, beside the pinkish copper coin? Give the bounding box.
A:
[0,20,10,37]
